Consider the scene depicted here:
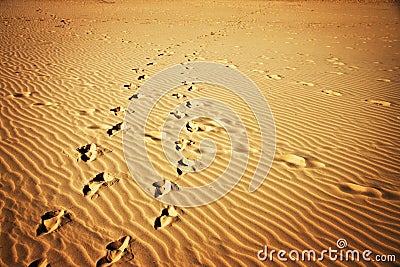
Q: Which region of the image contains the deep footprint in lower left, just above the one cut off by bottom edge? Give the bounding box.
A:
[36,210,72,236]
